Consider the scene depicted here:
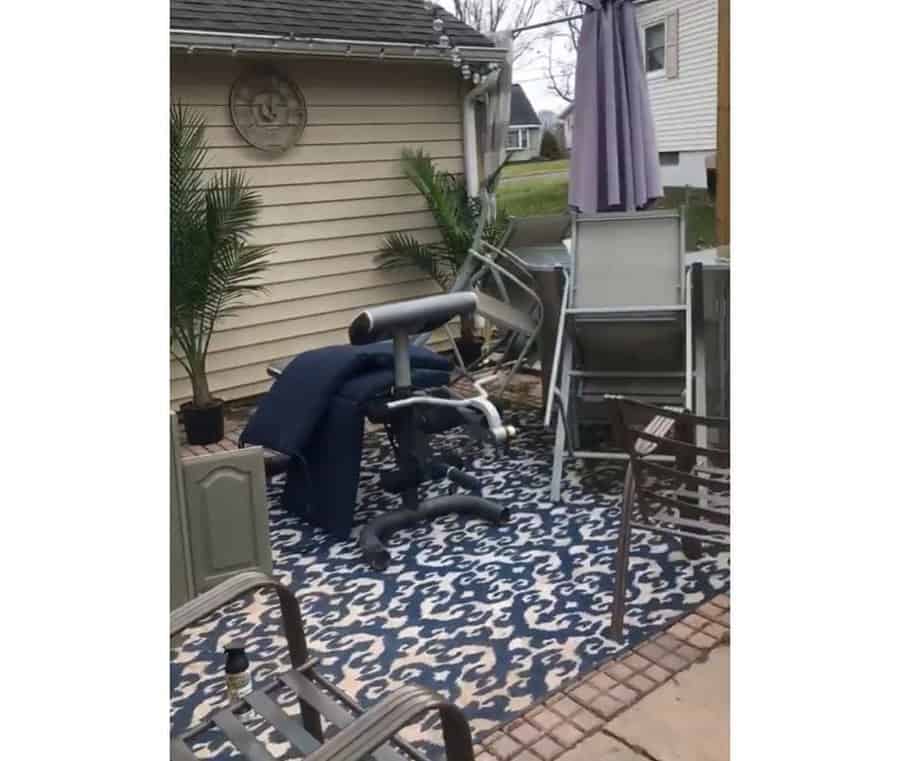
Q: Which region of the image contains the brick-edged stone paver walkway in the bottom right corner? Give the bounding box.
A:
[475,594,731,761]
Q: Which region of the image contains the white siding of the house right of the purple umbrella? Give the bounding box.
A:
[637,0,717,151]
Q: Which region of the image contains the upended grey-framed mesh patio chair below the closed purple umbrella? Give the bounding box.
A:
[544,211,693,501]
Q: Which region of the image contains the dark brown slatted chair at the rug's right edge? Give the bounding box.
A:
[607,396,730,642]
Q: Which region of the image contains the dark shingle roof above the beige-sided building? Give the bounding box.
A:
[169,0,493,47]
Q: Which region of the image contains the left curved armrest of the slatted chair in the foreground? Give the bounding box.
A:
[169,571,309,668]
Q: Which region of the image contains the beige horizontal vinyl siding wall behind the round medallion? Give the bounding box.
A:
[171,54,463,403]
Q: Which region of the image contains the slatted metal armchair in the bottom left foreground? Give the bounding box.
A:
[169,572,474,761]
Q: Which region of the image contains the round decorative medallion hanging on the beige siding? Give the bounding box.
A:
[229,69,306,153]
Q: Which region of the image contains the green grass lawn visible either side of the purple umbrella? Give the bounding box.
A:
[497,174,716,251]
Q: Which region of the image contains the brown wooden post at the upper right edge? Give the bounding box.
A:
[716,0,731,246]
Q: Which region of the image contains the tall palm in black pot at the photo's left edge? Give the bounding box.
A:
[169,104,270,444]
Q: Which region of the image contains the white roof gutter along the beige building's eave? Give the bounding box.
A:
[169,29,506,63]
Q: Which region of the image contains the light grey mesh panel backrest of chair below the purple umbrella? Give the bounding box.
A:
[570,210,684,308]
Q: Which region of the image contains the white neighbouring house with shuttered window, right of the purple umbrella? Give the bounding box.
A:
[635,0,718,187]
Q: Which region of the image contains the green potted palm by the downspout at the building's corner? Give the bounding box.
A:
[377,148,508,365]
